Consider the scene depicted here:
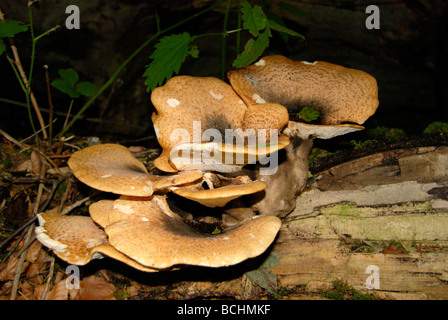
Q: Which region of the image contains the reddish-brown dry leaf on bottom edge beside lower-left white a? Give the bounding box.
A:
[75,275,115,300]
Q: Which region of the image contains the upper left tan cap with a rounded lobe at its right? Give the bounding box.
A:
[151,76,289,172]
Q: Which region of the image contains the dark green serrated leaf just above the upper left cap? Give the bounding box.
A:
[143,32,194,91]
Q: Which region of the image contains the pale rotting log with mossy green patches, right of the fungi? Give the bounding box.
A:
[136,147,448,299]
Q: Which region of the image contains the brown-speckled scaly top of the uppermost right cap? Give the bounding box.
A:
[228,56,378,124]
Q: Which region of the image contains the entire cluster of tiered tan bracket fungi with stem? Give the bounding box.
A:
[36,56,378,272]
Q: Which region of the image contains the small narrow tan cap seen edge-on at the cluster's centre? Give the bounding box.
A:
[171,181,267,208]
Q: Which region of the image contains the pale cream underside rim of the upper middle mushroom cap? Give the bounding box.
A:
[169,132,290,172]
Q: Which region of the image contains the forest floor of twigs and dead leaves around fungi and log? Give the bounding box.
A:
[0,129,448,300]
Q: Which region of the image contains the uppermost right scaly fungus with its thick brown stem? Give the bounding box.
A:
[228,56,379,216]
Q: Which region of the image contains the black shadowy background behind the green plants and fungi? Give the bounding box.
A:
[0,0,448,145]
